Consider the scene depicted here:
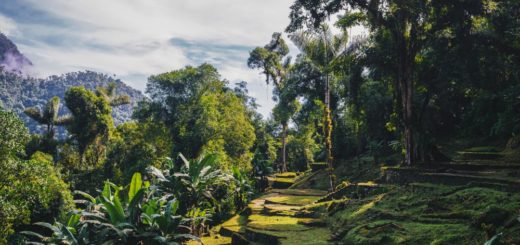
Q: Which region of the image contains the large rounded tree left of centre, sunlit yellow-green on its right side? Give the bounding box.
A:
[134,64,255,169]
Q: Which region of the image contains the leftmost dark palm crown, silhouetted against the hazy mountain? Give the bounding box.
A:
[24,96,71,139]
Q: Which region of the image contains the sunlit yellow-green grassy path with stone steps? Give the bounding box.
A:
[193,173,331,245]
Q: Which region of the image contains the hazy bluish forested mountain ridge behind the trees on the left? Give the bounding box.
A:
[0,33,145,138]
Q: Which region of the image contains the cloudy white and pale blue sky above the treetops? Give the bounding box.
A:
[0,0,297,116]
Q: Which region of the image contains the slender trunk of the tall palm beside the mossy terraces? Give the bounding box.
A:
[324,75,334,192]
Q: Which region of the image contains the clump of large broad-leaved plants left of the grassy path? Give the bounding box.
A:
[22,173,199,244]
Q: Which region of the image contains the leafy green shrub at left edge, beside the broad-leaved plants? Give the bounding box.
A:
[0,152,73,243]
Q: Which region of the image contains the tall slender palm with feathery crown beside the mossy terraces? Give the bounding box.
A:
[290,24,349,191]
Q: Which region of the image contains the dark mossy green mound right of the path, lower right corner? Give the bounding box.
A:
[329,183,520,244]
